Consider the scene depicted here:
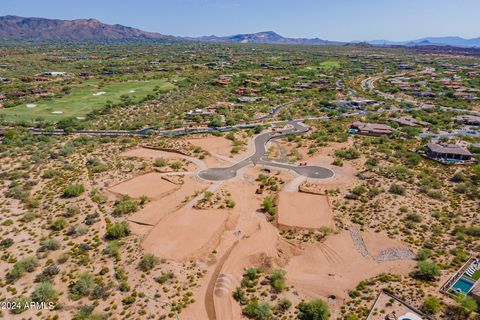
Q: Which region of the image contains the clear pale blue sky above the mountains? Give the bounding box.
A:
[0,0,480,41]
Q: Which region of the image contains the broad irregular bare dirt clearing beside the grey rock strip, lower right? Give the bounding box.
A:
[285,231,415,311]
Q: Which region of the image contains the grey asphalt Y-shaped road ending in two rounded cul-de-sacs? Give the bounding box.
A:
[198,121,334,181]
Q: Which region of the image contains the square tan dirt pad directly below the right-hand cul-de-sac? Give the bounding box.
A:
[278,192,335,229]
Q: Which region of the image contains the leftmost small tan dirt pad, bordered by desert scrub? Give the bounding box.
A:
[109,172,178,200]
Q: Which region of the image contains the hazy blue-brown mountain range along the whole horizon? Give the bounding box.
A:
[0,16,480,48]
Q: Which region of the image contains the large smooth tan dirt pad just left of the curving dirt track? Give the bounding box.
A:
[142,208,234,261]
